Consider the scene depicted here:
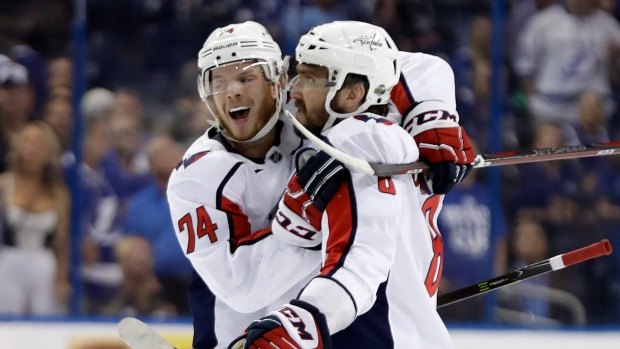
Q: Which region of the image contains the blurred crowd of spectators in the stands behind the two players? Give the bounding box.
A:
[0,0,620,325]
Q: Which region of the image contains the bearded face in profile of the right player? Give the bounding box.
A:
[291,63,329,134]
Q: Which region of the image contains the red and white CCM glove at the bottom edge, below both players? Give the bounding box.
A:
[228,299,332,349]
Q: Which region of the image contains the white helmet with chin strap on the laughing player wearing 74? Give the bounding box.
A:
[198,21,282,142]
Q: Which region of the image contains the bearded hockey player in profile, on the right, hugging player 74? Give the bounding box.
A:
[230,22,473,349]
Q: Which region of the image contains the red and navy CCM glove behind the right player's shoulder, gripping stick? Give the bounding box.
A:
[414,126,474,194]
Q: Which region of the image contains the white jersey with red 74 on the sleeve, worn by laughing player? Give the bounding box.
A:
[167,128,320,313]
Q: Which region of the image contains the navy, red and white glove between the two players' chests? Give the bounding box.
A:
[272,148,350,247]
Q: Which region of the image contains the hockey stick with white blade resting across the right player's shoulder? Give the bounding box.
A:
[285,110,620,176]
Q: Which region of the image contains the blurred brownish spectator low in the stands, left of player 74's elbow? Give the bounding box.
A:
[115,235,175,317]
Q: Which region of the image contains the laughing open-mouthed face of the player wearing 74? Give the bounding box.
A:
[207,62,277,141]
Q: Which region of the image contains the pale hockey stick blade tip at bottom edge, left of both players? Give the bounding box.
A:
[117,317,176,349]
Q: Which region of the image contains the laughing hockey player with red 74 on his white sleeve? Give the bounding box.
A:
[167,22,320,349]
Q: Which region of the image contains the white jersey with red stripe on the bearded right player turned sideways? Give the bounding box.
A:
[300,114,451,349]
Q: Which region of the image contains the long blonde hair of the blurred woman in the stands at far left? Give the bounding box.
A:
[7,121,63,190]
